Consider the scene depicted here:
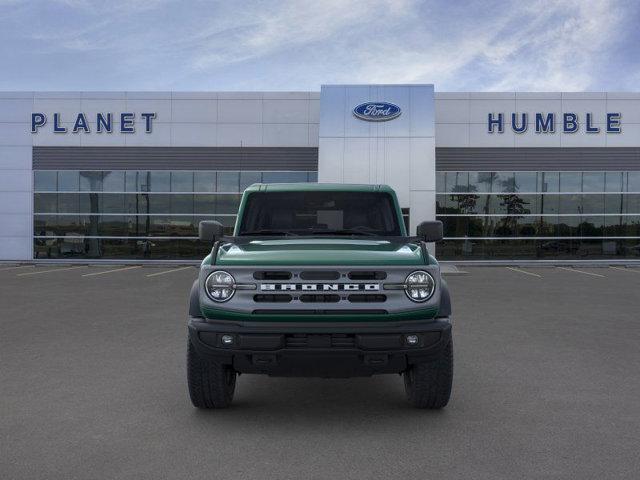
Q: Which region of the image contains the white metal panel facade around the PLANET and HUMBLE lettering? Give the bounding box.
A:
[0,85,640,260]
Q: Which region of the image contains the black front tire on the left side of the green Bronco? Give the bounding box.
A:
[187,341,237,408]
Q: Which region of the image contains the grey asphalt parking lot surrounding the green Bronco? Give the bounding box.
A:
[0,265,640,480]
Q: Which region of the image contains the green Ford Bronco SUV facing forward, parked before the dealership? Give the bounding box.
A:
[187,184,453,408]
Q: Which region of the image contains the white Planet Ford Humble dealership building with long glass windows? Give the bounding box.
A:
[0,85,640,261]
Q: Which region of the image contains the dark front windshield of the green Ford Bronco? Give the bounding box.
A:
[238,192,401,236]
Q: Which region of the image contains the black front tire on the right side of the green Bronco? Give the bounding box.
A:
[403,340,453,409]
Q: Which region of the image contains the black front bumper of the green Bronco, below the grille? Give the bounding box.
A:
[189,317,451,377]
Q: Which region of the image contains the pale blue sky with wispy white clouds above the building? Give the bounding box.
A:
[0,0,640,91]
